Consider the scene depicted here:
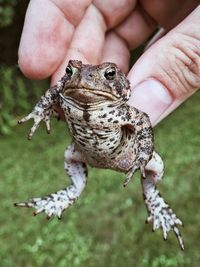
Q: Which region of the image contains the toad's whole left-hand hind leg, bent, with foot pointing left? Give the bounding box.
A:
[15,144,87,218]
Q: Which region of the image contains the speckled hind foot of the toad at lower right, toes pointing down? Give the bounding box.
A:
[145,190,184,250]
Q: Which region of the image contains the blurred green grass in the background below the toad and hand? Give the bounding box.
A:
[0,92,200,267]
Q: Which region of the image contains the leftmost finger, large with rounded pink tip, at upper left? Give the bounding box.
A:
[19,0,91,79]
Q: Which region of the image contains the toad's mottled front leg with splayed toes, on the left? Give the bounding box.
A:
[18,84,62,139]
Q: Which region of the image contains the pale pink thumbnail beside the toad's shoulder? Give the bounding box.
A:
[128,79,173,125]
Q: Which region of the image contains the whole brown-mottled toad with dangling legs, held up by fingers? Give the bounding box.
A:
[15,60,184,249]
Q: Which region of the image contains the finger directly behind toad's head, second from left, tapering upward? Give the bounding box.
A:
[52,5,107,83]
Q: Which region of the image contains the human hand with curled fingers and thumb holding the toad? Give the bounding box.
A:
[19,0,200,125]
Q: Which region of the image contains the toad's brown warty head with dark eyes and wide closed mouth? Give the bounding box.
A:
[62,60,130,103]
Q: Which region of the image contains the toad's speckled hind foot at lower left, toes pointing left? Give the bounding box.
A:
[15,187,77,219]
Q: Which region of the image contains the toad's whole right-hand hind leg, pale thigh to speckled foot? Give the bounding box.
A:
[141,152,184,249]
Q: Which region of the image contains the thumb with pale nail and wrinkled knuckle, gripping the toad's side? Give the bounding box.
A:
[128,6,200,125]
